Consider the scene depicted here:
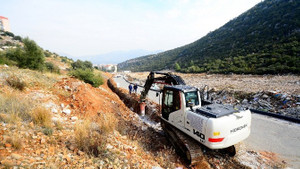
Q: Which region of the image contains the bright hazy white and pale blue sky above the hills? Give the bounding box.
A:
[0,0,261,60]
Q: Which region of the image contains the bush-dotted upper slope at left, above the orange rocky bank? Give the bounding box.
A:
[0,32,103,87]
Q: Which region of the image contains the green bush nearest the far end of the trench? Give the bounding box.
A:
[70,69,103,87]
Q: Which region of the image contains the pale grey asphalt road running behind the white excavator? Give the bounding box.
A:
[114,78,300,169]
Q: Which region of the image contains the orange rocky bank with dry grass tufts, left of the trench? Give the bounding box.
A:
[0,66,180,168]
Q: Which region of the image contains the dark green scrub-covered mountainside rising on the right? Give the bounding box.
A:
[118,0,300,74]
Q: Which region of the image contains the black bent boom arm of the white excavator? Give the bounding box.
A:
[140,72,185,102]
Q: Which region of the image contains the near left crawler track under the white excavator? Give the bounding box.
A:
[161,120,205,165]
